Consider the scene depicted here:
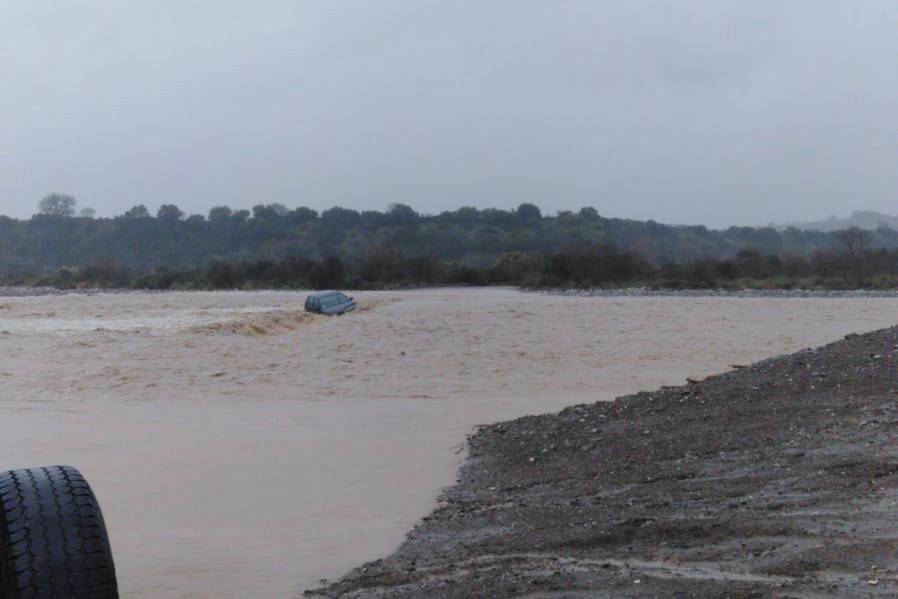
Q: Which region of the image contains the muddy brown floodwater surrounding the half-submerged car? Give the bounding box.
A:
[0,289,898,598]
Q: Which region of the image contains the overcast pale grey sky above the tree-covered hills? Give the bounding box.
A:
[0,0,898,226]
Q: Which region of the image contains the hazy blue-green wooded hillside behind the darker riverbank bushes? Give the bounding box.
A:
[8,200,898,277]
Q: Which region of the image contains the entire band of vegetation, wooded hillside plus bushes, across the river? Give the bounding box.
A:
[0,194,898,289]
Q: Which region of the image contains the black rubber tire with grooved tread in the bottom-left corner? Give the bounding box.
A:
[0,466,118,599]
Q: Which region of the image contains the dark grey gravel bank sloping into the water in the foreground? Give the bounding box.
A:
[307,328,898,598]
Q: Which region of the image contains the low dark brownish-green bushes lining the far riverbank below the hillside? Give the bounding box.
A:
[0,245,898,291]
